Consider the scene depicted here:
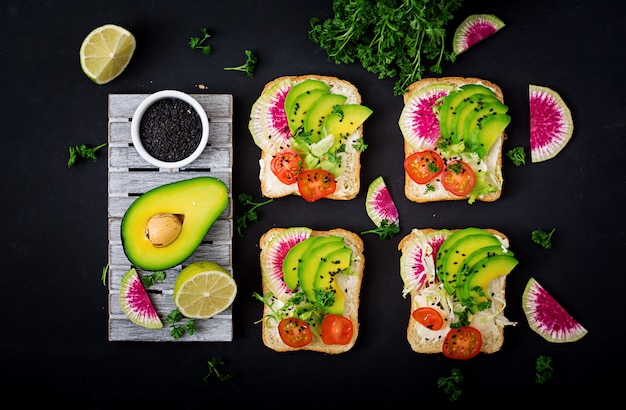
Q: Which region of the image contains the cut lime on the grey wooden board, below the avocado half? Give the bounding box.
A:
[174,261,237,319]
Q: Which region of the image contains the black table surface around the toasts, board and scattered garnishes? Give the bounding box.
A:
[0,0,626,409]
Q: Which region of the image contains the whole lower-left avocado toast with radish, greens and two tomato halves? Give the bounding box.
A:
[255,227,365,354]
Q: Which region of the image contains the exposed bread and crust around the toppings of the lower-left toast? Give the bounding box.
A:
[259,228,365,354]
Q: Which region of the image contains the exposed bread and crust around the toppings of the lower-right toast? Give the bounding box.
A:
[398,228,515,354]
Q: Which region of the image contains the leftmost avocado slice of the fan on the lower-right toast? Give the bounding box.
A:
[441,232,500,295]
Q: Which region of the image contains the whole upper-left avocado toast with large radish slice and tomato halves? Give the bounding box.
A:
[248,75,372,202]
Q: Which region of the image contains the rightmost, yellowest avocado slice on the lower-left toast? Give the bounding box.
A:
[313,246,352,315]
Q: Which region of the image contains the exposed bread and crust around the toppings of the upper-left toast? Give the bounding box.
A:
[251,74,363,200]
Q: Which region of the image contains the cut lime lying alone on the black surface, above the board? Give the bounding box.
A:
[80,24,136,84]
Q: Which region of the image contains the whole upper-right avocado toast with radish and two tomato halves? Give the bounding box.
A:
[398,77,511,203]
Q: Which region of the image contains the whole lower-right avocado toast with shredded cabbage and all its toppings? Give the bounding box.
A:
[398,227,518,360]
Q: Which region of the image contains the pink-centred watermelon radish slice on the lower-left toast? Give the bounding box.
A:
[261,227,312,302]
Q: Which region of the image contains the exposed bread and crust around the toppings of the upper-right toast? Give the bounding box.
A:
[403,77,506,203]
